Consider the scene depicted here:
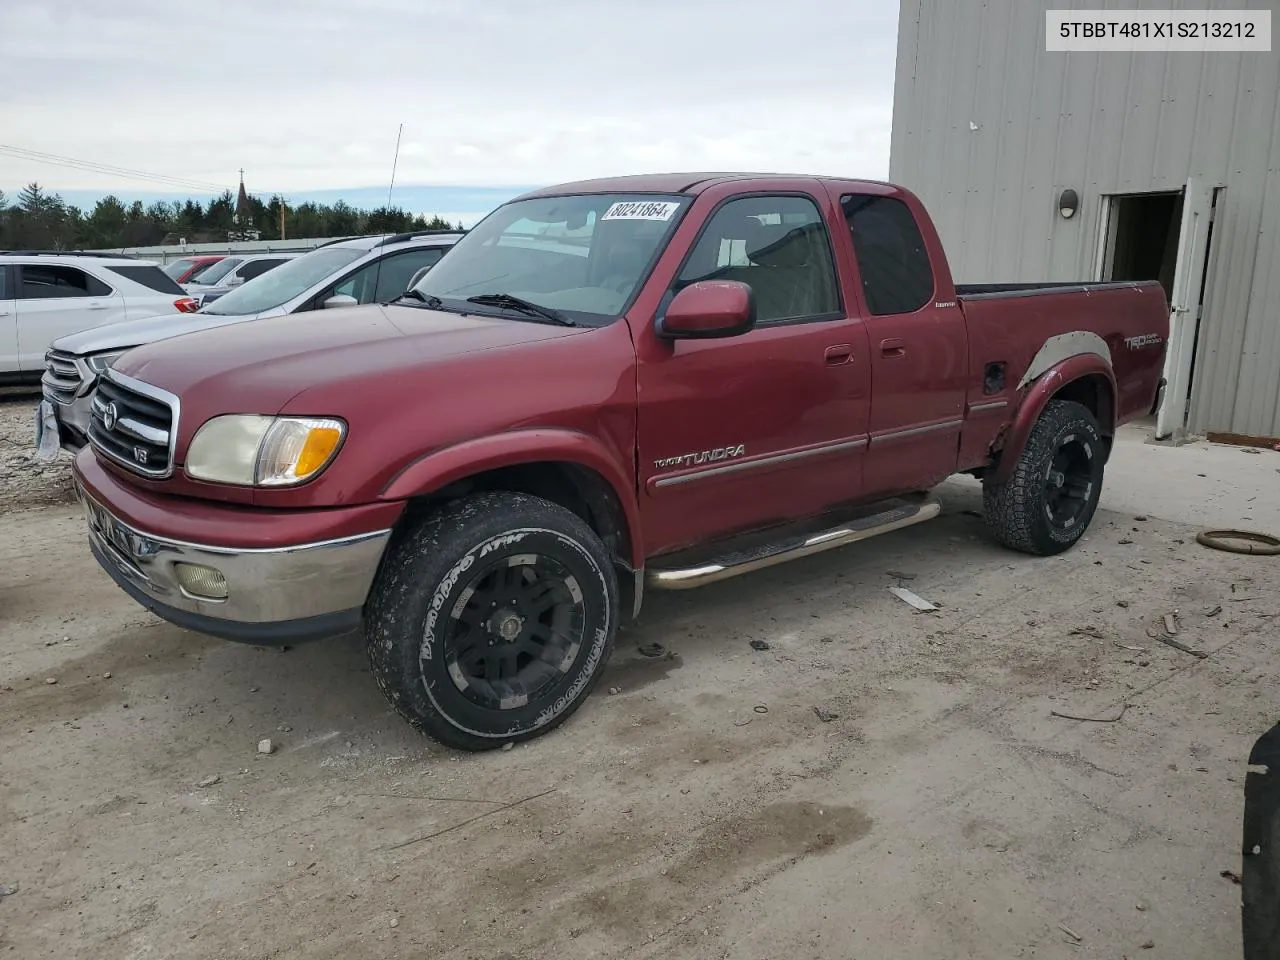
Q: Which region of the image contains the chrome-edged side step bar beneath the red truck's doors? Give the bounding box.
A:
[645,498,942,590]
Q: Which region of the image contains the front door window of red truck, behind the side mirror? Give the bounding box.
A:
[673,197,841,324]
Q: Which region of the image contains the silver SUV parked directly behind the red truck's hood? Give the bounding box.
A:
[37,230,462,458]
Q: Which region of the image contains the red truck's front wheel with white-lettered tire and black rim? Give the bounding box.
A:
[366,493,618,750]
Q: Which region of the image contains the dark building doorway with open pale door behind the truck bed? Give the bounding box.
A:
[1097,184,1222,440]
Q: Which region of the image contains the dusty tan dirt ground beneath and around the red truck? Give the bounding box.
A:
[0,391,1280,960]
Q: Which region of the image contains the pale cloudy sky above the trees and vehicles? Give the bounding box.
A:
[0,0,899,219]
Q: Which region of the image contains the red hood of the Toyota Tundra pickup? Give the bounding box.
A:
[115,306,591,416]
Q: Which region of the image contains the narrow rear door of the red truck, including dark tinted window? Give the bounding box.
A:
[840,193,969,495]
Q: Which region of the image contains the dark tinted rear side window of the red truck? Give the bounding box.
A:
[840,195,933,316]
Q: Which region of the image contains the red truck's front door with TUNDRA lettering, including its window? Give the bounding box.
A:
[637,195,870,553]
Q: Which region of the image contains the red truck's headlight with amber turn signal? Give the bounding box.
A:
[187,413,347,486]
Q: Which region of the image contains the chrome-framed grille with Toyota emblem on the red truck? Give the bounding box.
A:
[88,370,178,479]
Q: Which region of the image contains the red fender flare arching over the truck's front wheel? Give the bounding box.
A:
[379,429,644,570]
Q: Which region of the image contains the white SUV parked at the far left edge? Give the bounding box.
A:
[0,251,196,383]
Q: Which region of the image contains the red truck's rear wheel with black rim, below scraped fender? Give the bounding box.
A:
[982,401,1106,557]
